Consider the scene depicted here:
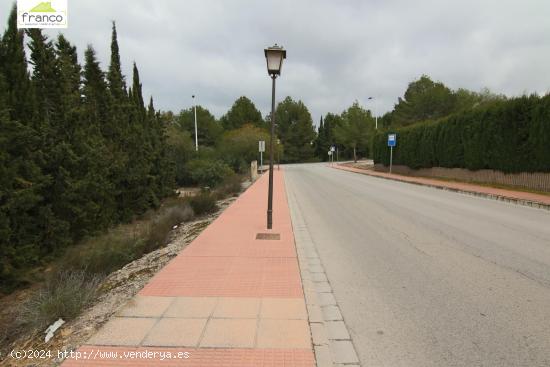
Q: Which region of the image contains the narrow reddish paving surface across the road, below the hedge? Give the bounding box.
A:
[334,166,550,205]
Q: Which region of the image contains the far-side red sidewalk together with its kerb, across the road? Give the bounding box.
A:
[332,165,550,210]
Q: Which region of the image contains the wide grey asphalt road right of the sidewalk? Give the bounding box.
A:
[285,164,550,367]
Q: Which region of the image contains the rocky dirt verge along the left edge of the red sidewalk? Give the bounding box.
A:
[0,188,246,366]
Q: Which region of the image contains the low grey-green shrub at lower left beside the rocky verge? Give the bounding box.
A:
[16,271,101,330]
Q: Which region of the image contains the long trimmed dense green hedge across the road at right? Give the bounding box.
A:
[373,95,550,172]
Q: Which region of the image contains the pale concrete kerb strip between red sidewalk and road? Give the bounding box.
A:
[288,182,360,367]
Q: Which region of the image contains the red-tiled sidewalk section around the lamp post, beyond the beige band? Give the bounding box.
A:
[139,172,303,298]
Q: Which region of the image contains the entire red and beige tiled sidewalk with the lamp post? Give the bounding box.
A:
[63,171,315,367]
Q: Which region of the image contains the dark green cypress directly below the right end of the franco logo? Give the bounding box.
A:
[53,35,113,241]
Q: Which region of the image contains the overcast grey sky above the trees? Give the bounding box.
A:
[0,0,550,123]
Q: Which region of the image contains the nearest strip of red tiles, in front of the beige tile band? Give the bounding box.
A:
[63,345,315,367]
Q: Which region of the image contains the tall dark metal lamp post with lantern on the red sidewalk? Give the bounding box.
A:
[264,44,286,229]
